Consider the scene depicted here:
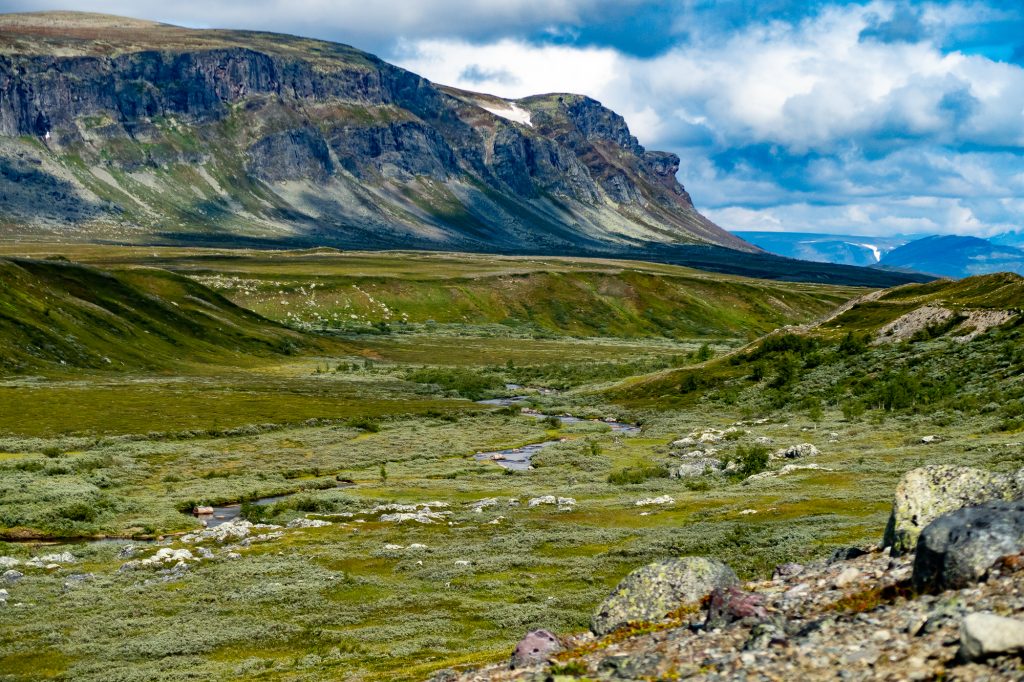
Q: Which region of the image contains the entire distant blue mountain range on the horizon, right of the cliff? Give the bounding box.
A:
[735,231,1024,278]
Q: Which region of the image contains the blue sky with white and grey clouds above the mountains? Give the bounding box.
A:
[6,0,1024,237]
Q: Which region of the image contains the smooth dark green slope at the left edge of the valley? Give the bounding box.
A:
[0,258,324,372]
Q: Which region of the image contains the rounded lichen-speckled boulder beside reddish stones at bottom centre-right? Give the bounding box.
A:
[590,556,739,635]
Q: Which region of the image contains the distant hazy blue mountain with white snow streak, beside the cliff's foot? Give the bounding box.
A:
[732,230,909,266]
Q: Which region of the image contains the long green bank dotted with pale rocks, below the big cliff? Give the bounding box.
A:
[0,245,865,339]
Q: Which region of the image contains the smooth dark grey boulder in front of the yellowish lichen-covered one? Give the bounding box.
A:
[913,500,1024,591]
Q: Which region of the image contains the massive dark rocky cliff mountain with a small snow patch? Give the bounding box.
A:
[0,13,754,251]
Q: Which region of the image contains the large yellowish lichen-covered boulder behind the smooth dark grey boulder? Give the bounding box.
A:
[882,465,1024,555]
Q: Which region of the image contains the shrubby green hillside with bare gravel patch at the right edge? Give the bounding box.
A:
[609,273,1024,413]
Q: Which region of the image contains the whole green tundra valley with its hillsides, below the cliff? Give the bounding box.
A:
[0,245,1024,680]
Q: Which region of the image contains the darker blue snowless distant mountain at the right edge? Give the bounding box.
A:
[882,235,1024,278]
